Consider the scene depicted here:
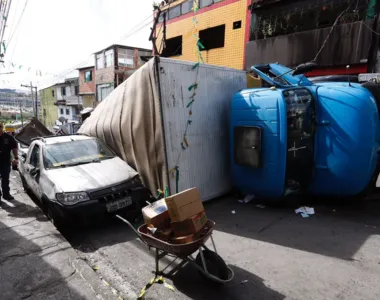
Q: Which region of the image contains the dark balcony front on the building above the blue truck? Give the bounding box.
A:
[245,22,372,70]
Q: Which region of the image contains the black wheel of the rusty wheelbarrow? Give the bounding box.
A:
[195,250,230,280]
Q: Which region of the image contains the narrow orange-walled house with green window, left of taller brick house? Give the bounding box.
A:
[77,66,96,108]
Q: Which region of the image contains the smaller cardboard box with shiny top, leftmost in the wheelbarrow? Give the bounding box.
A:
[142,199,170,229]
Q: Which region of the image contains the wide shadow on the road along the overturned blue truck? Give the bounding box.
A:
[205,197,380,260]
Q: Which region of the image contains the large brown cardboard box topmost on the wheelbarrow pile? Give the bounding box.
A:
[165,188,204,222]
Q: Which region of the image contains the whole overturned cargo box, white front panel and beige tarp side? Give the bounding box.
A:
[79,57,247,201]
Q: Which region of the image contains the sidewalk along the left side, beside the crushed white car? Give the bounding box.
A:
[0,172,117,300]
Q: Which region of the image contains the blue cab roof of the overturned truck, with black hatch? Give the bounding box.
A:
[230,89,287,198]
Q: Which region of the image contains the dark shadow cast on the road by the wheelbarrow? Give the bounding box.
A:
[171,265,285,300]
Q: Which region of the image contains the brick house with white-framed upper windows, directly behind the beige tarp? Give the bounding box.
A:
[95,45,152,102]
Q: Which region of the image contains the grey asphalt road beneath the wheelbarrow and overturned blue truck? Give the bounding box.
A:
[49,192,380,300]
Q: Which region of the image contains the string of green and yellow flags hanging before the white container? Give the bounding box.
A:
[169,0,205,193]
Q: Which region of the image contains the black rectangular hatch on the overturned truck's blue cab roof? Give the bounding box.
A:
[234,127,261,168]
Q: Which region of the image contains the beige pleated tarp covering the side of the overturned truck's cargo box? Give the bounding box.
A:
[78,59,168,194]
